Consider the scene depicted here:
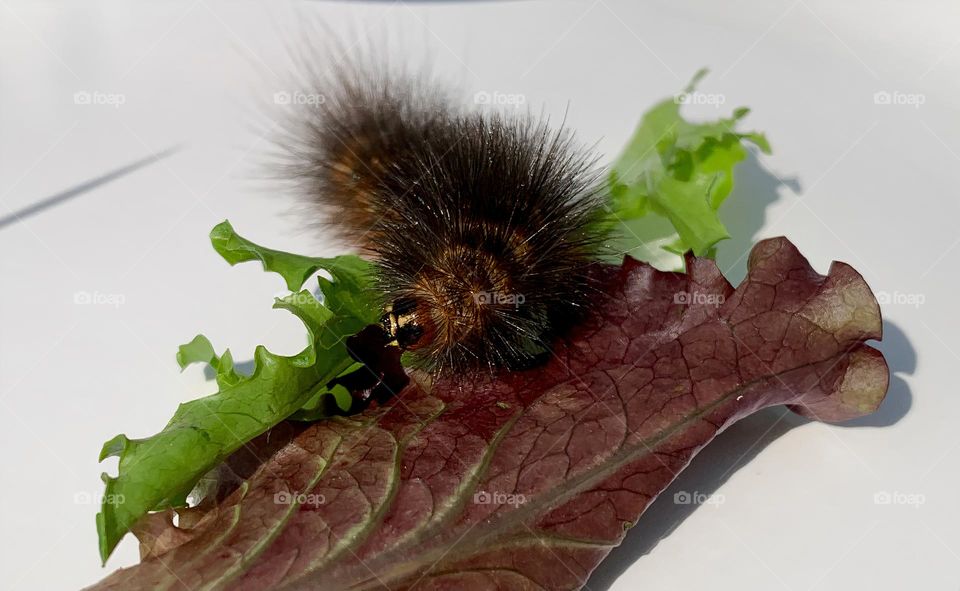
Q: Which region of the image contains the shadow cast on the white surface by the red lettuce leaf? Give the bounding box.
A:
[584,321,917,591]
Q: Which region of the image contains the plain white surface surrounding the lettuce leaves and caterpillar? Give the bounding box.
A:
[0,0,960,591]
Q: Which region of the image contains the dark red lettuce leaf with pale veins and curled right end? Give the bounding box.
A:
[88,238,888,590]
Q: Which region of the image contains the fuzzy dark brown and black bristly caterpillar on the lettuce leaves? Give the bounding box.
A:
[280,62,604,372]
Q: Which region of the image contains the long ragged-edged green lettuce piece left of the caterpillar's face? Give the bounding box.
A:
[97,222,380,562]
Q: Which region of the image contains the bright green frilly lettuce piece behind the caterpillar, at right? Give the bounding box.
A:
[609,70,770,263]
